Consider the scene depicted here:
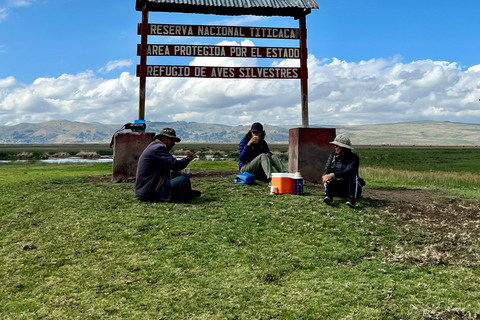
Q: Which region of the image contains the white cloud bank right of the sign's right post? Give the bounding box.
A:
[309,58,480,124]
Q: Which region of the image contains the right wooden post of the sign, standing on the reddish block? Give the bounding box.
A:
[298,11,309,128]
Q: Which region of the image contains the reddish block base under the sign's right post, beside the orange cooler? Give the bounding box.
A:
[288,128,336,183]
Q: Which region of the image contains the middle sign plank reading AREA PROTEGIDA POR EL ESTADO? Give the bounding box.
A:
[137,44,300,59]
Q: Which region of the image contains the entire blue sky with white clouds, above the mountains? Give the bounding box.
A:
[0,0,480,126]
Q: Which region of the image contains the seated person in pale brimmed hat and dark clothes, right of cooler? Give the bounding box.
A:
[322,134,364,208]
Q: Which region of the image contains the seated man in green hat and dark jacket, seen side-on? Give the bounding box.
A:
[135,128,201,202]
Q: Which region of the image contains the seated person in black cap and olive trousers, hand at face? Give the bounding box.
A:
[238,122,288,181]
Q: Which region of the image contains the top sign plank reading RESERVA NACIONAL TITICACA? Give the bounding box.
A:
[137,23,300,39]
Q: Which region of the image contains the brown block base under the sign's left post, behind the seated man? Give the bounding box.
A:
[112,132,155,182]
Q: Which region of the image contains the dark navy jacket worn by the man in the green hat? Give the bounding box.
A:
[135,141,190,201]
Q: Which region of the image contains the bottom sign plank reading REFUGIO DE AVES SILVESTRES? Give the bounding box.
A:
[137,65,300,79]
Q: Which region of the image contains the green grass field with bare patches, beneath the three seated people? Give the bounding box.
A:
[0,148,480,319]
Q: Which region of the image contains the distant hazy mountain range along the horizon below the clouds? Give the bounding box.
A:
[0,120,480,146]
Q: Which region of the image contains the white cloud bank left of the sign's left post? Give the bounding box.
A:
[0,71,138,124]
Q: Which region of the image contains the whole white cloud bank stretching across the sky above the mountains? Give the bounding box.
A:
[0,54,480,125]
